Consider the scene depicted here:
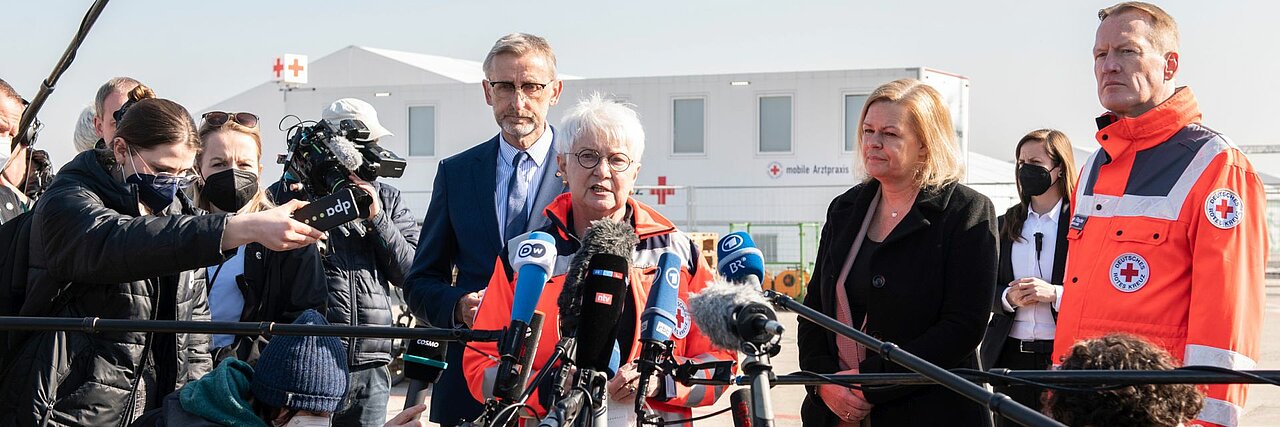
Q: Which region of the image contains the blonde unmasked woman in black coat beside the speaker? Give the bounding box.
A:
[799,79,996,426]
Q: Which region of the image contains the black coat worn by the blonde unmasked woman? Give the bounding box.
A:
[797,180,997,426]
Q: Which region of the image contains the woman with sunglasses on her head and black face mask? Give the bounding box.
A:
[196,111,329,364]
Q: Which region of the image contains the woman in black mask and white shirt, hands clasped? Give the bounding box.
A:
[980,129,1075,426]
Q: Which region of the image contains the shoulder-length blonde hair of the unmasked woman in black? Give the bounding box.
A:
[858,78,964,187]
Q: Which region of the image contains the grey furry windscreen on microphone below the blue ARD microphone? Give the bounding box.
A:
[689,281,769,352]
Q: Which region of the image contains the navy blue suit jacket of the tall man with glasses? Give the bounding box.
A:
[404,128,564,426]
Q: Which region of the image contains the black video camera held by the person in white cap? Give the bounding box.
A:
[276,119,406,231]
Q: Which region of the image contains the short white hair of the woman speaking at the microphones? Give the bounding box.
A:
[556,92,644,162]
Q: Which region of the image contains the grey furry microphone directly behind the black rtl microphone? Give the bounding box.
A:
[556,220,640,338]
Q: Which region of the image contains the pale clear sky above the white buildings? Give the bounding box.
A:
[0,0,1280,173]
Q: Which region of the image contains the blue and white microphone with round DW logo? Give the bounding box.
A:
[493,231,557,401]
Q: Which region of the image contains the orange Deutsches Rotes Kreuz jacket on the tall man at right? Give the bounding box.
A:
[1053,87,1267,426]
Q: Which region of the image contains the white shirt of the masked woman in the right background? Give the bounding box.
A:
[1000,199,1062,340]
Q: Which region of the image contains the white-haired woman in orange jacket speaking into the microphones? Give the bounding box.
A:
[463,95,736,421]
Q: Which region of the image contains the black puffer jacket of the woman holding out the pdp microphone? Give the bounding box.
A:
[0,151,227,426]
